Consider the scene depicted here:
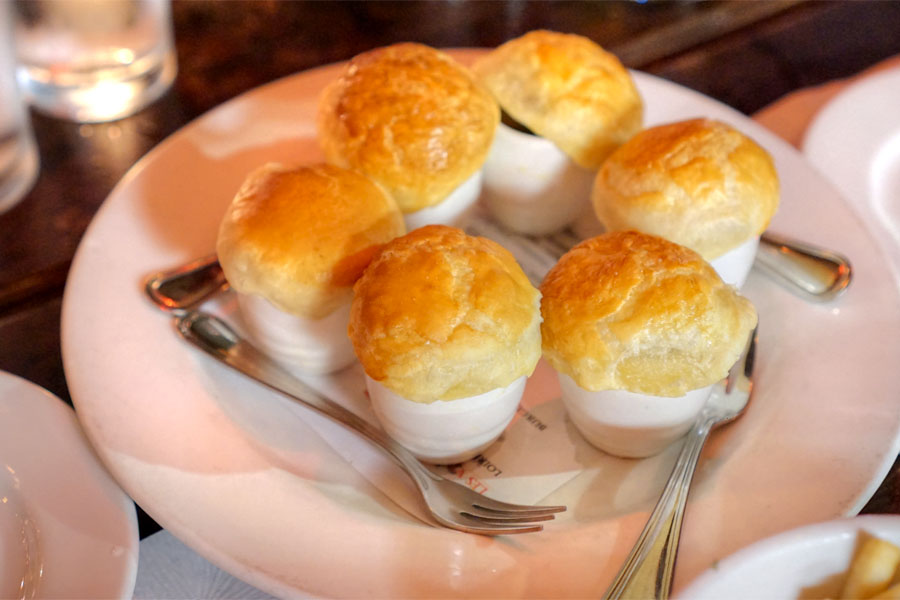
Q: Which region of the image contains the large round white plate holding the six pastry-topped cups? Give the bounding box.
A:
[63,51,900,597]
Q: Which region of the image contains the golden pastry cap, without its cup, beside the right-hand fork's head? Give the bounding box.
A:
[541,231,756,397]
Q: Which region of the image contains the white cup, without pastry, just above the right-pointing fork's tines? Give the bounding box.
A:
[366,375,526,464]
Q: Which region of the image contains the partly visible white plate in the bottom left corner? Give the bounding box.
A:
[0,371,138,598]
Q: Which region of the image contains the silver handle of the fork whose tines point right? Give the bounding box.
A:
[175,311,438,490]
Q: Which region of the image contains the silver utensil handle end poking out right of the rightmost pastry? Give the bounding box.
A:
[756,233,852,302]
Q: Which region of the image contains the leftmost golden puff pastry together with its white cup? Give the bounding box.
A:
[216,163,406,374]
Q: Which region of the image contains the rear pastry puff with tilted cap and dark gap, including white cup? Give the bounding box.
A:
[472,30,643,234]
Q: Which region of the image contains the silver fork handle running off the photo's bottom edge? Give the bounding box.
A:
[603,418,714,600]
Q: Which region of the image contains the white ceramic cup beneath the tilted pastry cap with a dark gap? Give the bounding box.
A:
[481,123,594,235]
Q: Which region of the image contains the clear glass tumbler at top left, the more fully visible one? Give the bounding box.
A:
[13,0,176,123]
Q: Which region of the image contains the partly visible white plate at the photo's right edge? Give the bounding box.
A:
[803,69,900,277]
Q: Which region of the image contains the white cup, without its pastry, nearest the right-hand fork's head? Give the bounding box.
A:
[558,373,712,458]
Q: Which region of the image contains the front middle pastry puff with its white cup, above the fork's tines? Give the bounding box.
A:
[348,225,541,464]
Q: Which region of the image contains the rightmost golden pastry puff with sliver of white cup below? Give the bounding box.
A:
[592,119,779,287]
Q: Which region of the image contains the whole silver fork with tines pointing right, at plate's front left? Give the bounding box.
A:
[175,311,566,535]
